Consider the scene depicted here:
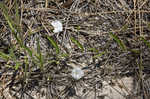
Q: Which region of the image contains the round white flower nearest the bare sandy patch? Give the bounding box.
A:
[71,67,84,80]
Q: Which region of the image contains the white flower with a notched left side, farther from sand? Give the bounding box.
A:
[51,20,63,33]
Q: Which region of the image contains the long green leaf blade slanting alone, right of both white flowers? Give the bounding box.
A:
[109,32,127,51]
